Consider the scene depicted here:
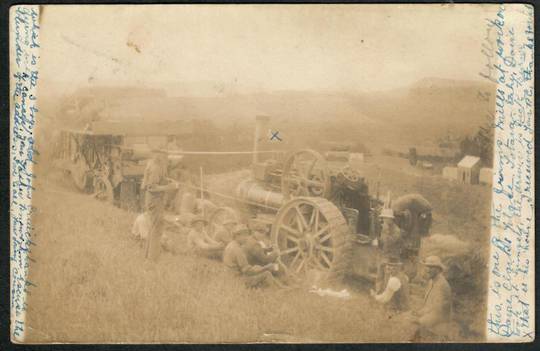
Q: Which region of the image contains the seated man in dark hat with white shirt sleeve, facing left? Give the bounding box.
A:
[370,259,410,314]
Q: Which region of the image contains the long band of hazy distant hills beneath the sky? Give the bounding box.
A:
[39,78,495,151]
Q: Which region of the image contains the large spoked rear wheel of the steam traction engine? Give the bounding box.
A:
[272,197,351,279]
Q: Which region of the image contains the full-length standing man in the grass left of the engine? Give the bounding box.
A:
[141,148,178,261]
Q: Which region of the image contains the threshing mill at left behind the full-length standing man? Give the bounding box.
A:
[55,120,192,211]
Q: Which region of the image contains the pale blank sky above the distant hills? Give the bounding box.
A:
[40,4,495,92]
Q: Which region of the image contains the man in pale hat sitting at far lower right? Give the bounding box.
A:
[413,256,452,340]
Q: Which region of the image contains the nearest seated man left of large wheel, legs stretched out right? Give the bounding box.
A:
[223,226,283,288]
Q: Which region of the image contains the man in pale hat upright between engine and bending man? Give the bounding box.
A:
[375,207,403,294]
